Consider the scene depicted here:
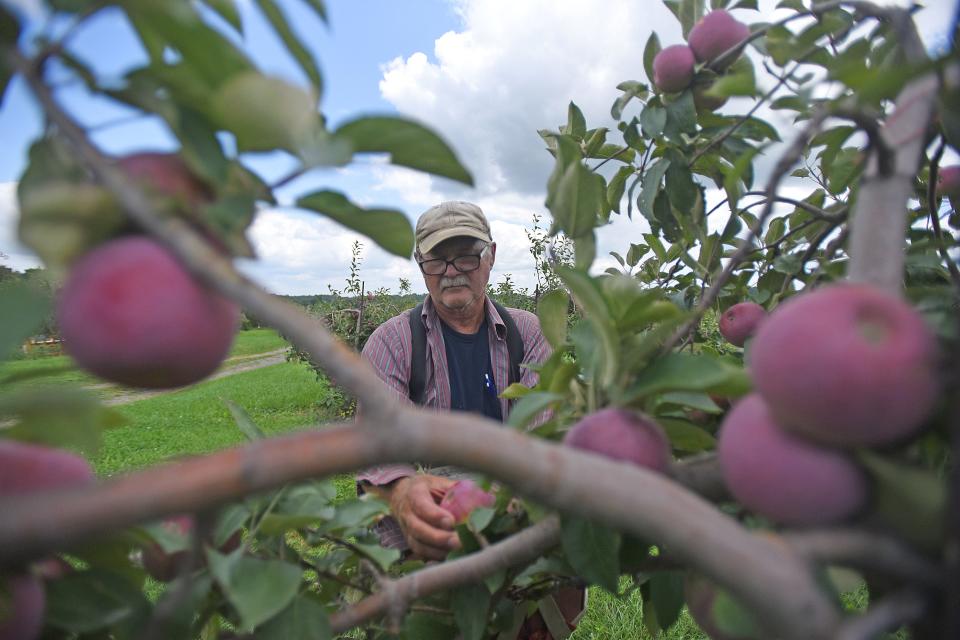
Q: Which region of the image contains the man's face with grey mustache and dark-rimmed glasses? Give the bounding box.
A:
[419,237,497,311]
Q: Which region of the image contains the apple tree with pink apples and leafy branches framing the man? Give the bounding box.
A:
[0,0,960,640]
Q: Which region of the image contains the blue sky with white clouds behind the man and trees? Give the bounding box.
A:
[0,0,955,294]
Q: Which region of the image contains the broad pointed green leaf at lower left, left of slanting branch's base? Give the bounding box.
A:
[207,548,302,633]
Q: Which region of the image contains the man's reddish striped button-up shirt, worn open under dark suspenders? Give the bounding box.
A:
[357,296,551,485]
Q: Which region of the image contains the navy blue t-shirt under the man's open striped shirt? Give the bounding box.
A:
[440,318,503,422]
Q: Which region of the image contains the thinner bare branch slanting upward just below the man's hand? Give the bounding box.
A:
[330,516,560,633]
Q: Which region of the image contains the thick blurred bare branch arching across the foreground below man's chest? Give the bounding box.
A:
[0,416,838,640]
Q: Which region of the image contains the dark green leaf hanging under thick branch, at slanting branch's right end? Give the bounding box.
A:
[560,516,620,593]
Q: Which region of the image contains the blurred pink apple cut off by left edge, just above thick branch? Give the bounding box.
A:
[0,440,95,496]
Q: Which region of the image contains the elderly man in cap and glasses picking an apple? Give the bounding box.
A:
[357,201,550,560]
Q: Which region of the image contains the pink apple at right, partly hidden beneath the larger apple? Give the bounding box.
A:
[717,394,868,526]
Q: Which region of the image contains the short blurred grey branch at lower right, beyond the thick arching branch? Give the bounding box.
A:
[783,529,944,587]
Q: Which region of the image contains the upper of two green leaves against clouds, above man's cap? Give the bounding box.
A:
[334,116,473,186]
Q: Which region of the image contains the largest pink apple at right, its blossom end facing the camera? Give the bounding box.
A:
[750,283,939,447]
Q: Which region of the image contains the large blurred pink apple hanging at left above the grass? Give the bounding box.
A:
[57,236,240,388]
